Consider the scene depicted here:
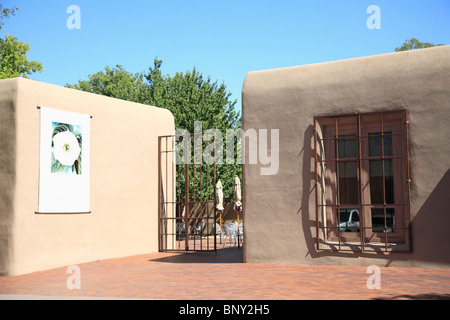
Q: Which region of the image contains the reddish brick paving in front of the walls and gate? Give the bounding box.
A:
[0,247,450,300]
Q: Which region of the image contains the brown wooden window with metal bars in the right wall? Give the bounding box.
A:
[314,110,410,251]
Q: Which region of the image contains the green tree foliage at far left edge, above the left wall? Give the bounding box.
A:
[0,4,42,79]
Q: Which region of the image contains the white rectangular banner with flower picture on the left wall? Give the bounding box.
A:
[37,107,91,213]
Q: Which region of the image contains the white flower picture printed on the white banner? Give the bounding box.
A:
[51,122,83,175]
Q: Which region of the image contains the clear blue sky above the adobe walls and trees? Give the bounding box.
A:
[0,0,450,115]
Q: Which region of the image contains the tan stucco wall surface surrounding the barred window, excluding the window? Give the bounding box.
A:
[242,46,450,267]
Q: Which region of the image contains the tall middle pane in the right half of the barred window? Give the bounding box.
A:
[369,160,394,204]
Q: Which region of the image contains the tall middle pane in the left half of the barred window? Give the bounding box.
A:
[339,161,358,204]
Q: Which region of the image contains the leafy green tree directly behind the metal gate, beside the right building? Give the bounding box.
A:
[143,59,242,202]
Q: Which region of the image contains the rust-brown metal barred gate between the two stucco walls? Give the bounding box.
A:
[158,132,218,252]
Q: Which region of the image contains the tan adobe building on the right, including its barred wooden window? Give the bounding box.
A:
[242,46,450,268]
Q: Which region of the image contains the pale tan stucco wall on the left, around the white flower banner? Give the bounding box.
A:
[0,78,174,275]
